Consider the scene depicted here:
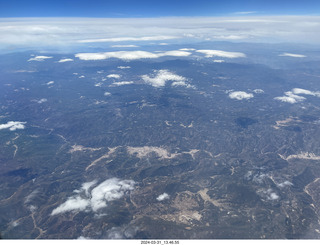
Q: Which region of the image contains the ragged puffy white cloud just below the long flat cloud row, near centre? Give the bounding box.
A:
[141,70,187,88]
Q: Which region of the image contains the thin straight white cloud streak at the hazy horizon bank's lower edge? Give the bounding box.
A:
[78,36,178,43]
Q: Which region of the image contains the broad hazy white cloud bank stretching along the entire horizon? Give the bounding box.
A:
[0,16,320,51]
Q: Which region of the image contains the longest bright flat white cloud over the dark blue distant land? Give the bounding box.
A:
[75,50,191,60]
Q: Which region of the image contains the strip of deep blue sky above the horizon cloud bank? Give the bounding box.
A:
[0,0,320,18]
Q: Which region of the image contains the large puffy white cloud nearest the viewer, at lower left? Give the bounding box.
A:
[51,178,135,215]
